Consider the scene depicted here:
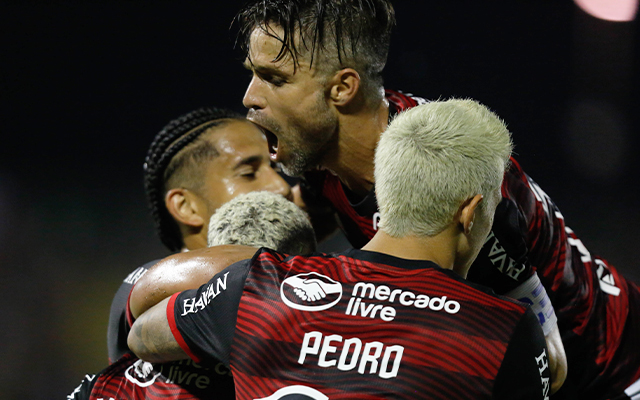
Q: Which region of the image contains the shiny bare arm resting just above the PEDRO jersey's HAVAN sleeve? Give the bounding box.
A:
[129,245,257,319]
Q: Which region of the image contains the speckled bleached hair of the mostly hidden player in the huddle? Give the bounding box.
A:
[207,192,316,254]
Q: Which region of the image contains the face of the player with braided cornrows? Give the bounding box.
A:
[200,120,292,212]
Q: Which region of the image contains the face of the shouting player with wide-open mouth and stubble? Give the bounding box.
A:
[243,27,338,176]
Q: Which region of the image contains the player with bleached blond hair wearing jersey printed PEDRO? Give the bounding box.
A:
[129,100,550,399]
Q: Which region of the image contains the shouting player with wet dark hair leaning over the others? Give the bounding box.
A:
[238,0,640,399]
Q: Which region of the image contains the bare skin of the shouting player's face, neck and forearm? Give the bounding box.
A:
[243,24,567,393]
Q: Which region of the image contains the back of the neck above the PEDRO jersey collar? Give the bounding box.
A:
[362,227,468,278]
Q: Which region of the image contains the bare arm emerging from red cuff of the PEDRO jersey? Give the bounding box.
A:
[127,299,189,362]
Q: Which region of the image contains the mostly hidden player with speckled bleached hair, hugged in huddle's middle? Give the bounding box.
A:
[68,192,316,400]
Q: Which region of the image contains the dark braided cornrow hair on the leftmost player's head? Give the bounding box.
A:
[144,107,244,251]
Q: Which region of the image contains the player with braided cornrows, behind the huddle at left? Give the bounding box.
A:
[107,107,292,396]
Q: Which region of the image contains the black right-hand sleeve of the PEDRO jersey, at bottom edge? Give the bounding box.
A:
[493,309,551,400]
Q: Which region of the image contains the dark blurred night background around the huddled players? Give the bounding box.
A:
[0,0,640,399]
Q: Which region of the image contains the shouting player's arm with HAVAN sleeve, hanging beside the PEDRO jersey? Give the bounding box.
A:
[468,160,567,393]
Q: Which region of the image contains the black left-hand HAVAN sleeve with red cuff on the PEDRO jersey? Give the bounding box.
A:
[167,260,251,365]
